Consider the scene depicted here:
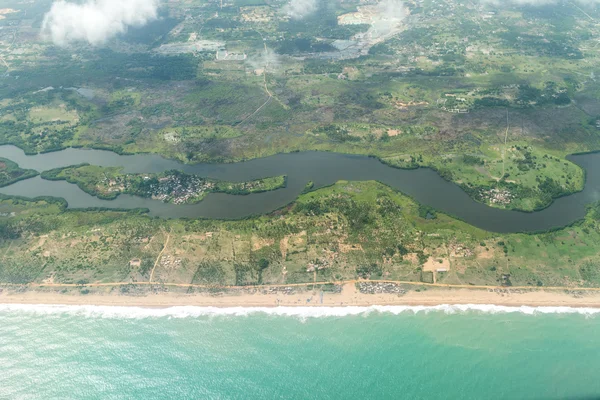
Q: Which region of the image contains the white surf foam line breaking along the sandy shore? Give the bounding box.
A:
[0,304,600,319]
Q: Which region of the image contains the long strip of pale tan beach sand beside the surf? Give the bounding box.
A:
[0,284,600,308]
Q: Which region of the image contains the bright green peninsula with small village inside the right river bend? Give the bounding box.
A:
[384,143,585,211]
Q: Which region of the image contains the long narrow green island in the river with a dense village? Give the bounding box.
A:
[41,164,287,204]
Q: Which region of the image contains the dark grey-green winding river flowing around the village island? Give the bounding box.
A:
[0,145,600,233]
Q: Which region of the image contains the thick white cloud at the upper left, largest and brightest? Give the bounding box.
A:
[42,0,159,46]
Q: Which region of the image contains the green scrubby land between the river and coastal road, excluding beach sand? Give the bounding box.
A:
[0,182,600,287]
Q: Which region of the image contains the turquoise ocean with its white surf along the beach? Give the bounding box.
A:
[0,305,600,399]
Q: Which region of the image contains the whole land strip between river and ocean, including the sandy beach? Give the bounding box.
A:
[0,181,600,306]
